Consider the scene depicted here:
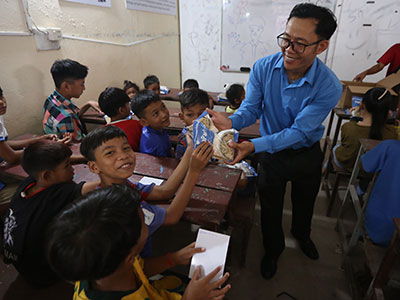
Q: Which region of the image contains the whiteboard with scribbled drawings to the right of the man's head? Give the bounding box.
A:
[331,0,400,82]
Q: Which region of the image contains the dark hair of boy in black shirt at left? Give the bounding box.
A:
[21,139,72,179]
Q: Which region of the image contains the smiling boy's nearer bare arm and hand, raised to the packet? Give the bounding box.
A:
[163,142,213,225]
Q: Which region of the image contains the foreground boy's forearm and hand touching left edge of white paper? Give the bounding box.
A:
[144,242,205,277]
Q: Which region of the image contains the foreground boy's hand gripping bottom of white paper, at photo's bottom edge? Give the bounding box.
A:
[182,267,231,300]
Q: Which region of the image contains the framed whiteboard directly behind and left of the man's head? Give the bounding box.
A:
[221,0,336,71]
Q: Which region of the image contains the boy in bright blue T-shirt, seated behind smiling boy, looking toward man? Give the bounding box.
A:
[131,90,173,157]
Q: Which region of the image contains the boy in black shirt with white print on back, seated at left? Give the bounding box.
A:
[4,140,98,287]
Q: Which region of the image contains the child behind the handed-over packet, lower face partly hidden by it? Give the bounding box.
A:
[175,88,209,159]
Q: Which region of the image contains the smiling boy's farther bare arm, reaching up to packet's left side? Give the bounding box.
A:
[146,147,193,202]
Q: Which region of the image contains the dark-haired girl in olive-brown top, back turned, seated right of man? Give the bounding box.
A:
[333,88,397,172]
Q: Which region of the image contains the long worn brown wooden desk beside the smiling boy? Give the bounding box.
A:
[0,144,241,230]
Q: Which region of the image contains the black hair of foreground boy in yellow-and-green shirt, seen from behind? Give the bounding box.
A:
[47,185,142,281]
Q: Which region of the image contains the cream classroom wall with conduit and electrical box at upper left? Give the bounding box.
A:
[0,0,180,137]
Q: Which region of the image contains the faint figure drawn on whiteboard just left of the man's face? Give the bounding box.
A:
[240,17,267,66]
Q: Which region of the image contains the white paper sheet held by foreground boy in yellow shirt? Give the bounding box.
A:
[189,229,230,281]
